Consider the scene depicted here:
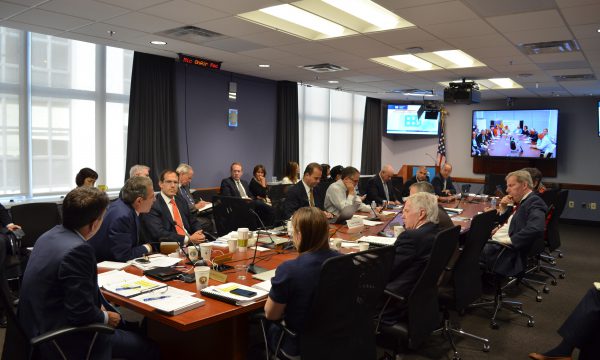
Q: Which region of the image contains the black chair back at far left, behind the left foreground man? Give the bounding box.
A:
[10,203,62,248]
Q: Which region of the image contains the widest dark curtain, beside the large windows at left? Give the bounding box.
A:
[125,52,179,187]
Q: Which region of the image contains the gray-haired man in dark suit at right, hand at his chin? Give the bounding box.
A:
[482,170,548,276]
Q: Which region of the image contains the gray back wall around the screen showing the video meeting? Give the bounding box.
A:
[381,97,600,221]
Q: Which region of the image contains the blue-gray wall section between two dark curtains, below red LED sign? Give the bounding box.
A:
[175,64,276,188]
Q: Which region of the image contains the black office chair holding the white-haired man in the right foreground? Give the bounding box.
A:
[376,226,460,358]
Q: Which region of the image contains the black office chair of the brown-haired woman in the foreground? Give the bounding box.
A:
[261,246,394,360]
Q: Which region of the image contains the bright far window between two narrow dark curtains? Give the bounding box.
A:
[298,85,366,170]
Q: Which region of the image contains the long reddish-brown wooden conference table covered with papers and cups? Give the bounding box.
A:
[99,199,489,360]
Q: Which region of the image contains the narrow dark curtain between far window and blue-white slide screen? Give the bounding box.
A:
[360,97,383,174]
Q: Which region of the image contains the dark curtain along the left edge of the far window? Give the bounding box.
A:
[273,81,300,178]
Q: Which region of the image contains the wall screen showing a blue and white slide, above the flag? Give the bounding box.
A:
[386,104,440,136]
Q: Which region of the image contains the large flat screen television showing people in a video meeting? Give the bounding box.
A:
[471,109,558,159]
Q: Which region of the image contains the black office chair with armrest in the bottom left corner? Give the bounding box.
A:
[0,239,114,360]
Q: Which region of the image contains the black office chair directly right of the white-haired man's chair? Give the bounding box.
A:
[436,211,496,359]
